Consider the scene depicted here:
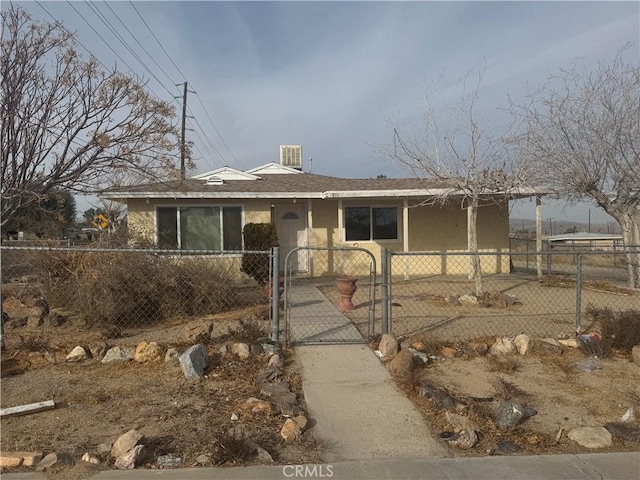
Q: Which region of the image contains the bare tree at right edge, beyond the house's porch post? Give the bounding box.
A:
[510,46,640,288]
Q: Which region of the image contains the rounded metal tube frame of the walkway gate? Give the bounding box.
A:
[283,246,379,345]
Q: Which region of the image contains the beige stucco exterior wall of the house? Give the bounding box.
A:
[127,195,509,275]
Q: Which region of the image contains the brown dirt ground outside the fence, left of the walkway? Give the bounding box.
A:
[1,307,319,478]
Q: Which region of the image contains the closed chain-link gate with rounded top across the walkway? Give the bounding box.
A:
[283,247,377,345]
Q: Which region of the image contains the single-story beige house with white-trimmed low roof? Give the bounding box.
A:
[100,156,528,275]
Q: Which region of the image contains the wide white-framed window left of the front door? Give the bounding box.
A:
[156,206,242,250]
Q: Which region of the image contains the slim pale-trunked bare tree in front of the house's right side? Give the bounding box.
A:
[382,73,526,296]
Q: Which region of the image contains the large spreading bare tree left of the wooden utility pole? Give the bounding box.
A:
[0,4,188,226]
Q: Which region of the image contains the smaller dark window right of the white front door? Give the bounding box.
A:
[344,207,398,242]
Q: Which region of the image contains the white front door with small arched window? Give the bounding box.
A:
[274,204,308,273]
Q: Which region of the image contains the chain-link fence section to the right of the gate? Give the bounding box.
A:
[382,251,640,341]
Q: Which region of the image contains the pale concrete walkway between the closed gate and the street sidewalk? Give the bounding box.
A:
[295,345,447,462]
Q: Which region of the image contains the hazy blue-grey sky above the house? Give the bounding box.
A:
[19,1,640,222]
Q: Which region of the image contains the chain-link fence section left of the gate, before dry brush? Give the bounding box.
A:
[1,245,271,338]
